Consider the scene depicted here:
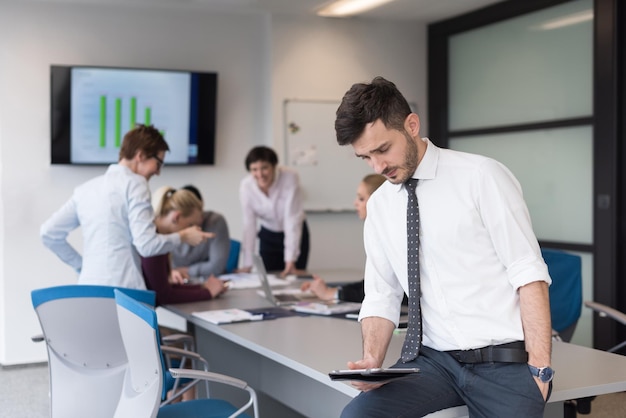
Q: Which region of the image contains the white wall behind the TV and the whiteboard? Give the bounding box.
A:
[0,0,426,365]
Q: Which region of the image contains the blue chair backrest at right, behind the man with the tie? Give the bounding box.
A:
[541,248,582,341]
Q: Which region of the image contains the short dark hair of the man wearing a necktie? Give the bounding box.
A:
[335,76,411,145]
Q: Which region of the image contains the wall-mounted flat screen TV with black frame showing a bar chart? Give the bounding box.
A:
[50,65,217,165]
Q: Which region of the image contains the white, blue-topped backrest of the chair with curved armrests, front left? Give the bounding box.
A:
[112,290,165,418]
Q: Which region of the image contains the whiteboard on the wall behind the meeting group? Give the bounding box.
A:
[284,100,373,211]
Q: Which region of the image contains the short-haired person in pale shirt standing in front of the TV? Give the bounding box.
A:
[40,125,212,289]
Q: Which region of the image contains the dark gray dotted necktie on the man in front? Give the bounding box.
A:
[402,179,422,363]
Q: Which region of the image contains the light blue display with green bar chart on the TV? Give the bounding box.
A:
[71,68,191,163]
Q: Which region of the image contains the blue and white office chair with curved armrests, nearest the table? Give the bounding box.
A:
[113,290,259,418]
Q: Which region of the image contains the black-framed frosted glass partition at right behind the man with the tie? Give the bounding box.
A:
[429,0,597,346]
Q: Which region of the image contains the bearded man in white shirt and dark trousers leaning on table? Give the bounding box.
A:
[335,77,553,418]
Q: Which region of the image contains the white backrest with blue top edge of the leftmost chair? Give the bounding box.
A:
[31,285,155,418]
